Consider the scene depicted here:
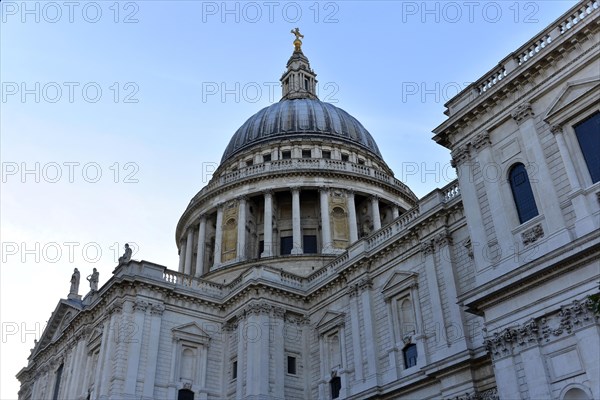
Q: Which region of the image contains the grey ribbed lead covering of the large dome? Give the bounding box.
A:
[221,99,382,163]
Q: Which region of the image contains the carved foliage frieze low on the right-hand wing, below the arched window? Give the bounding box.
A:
[483,298,597,360]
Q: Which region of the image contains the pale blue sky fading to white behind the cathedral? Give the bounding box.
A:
[0,1,575,400]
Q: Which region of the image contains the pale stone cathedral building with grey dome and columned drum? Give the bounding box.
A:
[18,1,600,400]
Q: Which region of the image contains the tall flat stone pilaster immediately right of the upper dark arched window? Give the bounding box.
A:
[511,102,565,235]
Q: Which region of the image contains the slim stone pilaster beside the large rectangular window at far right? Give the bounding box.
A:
[550,125,595,237]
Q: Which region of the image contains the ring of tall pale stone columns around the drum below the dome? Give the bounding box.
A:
[179,187,400,277]
